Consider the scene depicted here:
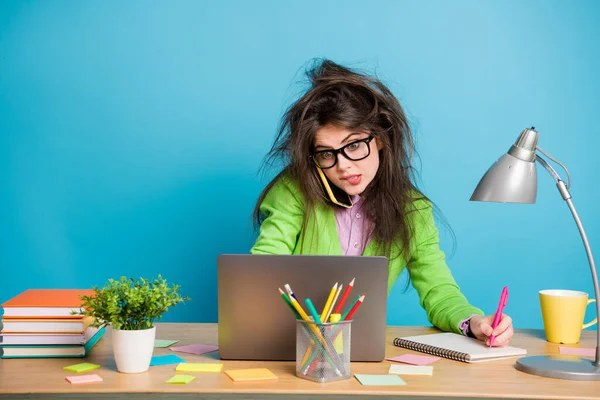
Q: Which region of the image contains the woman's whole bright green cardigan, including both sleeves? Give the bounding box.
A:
[250,177,483,333]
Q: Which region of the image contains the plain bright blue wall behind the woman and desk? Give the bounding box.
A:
[0,0,600,328]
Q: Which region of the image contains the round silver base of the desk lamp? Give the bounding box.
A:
[516,356,600,381]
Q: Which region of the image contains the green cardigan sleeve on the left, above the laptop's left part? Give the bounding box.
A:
[250,177,304,254]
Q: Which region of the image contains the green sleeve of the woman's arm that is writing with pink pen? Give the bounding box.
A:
[408,200,483,333]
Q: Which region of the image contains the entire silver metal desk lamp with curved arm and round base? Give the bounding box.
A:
[471,127,600,380]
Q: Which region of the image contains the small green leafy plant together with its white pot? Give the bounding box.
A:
[78,275,189,373]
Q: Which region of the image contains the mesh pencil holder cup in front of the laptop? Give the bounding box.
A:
[296,320,352,383]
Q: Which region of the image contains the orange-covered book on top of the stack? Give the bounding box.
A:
[2,289,94,319]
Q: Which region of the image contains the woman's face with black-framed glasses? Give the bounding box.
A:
[313,125,381,196]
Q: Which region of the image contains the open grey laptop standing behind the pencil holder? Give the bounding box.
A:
[217,254,388,361]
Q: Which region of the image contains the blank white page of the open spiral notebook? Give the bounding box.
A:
[402,332,527,362]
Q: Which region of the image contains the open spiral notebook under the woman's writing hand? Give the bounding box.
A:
[394,332,527,362]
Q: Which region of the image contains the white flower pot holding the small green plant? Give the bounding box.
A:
[112,326,156,374]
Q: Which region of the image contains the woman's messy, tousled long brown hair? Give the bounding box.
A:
[253,60,427,259]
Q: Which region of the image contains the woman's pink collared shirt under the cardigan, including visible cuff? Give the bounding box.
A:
[335,195,472,336]
